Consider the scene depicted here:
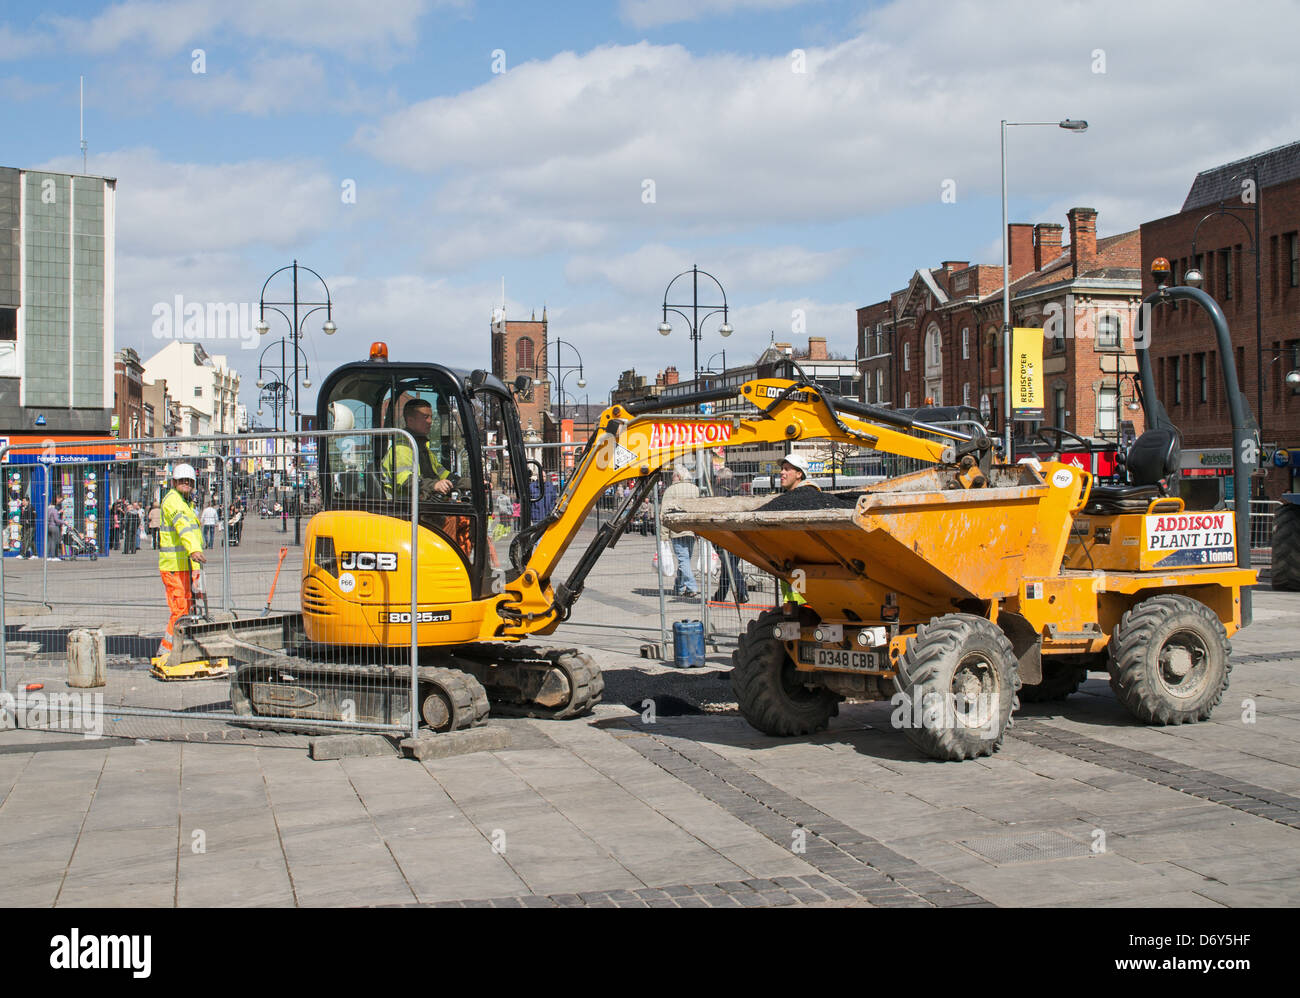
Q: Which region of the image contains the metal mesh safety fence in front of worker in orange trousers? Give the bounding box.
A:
[0,428,418,737]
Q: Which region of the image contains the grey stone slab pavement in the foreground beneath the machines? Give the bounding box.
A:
[0,591,1300,907]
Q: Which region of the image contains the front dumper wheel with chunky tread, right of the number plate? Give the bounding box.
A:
[891,613,1021,761]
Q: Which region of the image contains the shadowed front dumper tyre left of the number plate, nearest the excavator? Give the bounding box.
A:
[731,609,842,737]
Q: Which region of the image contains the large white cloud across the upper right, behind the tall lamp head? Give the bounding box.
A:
[355,0,1300,268]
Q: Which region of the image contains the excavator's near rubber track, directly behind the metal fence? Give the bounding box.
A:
[230,656,490,734]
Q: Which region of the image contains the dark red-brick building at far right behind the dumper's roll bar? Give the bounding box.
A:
[1140,142,1300,499]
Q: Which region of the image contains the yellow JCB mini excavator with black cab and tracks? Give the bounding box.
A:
[176,343,991,732]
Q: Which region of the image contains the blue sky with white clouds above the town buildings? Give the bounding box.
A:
[0,0,1300,412]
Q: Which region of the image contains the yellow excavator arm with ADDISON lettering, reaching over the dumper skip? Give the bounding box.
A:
[495,378,992,637]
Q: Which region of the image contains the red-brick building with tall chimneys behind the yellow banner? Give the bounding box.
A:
[858,208,1141,449]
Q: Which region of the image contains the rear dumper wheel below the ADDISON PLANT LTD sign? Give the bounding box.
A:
[1109,594,1232,724]
